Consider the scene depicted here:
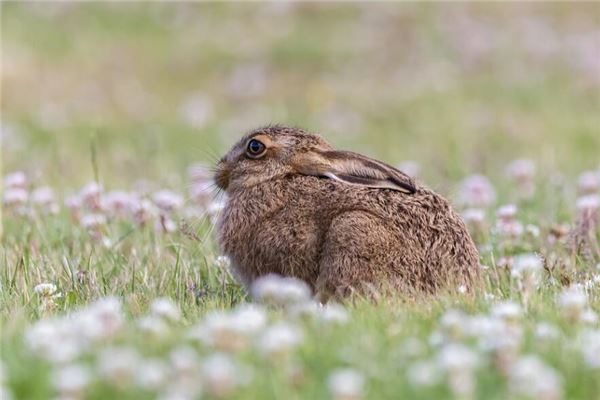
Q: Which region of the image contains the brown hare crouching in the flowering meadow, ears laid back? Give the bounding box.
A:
[215,126,479,298]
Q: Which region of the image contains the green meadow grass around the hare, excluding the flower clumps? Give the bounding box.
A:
[0,2,600,399]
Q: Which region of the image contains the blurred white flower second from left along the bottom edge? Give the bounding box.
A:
[97,347,141,387]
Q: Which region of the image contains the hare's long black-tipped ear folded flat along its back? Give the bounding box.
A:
[294,150,417,194]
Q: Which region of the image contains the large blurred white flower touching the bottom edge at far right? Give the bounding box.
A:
[509,355,562,400]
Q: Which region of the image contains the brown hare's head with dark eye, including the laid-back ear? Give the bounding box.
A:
[215,126,416,193]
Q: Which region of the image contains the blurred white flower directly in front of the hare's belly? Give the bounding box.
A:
[250,274,311,306]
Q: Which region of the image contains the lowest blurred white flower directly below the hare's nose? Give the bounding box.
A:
[202,354,247,397]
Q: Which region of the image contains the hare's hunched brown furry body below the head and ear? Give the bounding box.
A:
[218,128,478,295]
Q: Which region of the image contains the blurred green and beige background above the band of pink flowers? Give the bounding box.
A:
[1,2,600,191]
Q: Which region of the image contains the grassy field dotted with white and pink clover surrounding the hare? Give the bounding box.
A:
[0,2,600,400]
